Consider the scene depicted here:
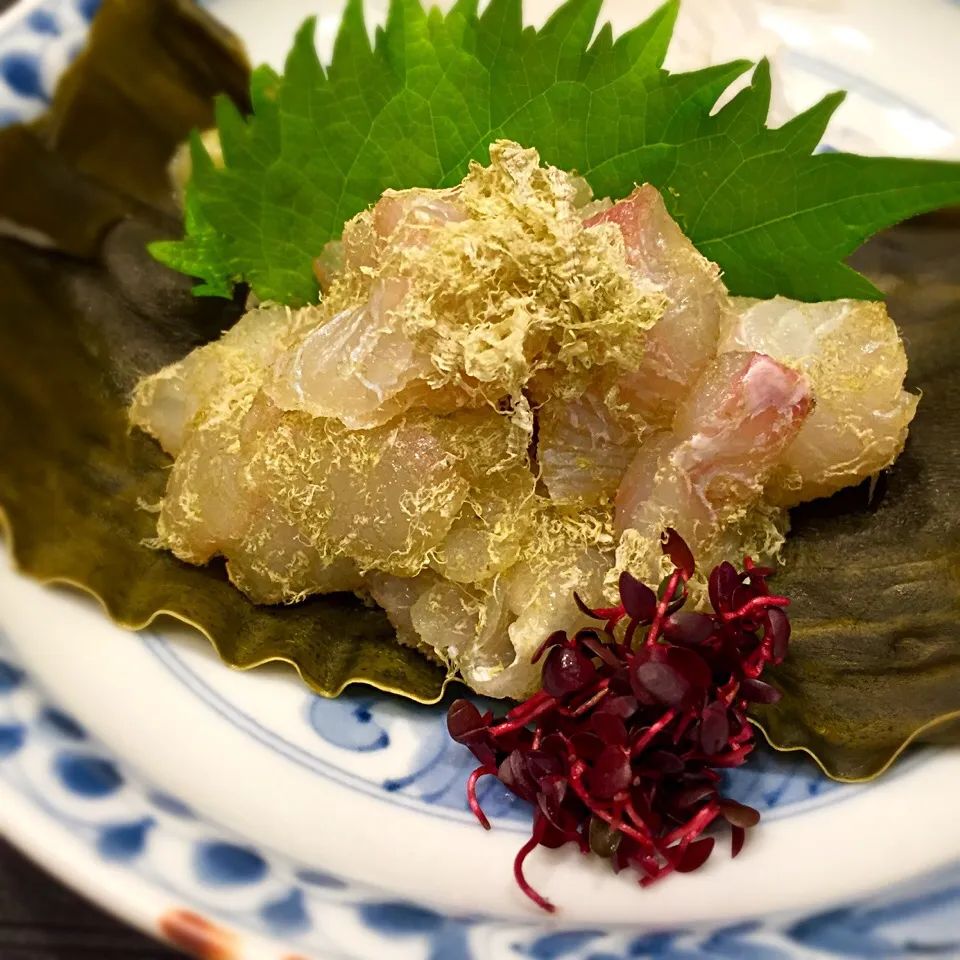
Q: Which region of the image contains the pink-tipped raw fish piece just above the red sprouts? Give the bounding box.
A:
[616,352,813,576]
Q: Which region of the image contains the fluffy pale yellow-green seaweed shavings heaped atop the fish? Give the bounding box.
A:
[324,141,665,401]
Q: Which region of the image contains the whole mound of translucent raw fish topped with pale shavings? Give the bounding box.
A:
[130,143,917,697]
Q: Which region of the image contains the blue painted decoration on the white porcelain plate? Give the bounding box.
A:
[0,0,960,960]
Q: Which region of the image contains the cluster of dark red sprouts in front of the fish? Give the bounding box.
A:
[447,530,790,912]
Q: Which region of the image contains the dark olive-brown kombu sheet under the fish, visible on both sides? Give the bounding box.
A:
[0,0,960,779]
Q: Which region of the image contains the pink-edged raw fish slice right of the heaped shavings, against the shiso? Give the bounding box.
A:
[586,184,730,427]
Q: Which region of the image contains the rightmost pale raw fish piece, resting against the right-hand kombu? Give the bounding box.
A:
[721,297,919,506]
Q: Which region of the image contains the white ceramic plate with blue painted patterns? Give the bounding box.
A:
[0,0,960,960]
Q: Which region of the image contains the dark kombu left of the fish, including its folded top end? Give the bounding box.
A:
[0,0,445,701]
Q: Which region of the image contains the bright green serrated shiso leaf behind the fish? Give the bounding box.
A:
[154,0,960,304]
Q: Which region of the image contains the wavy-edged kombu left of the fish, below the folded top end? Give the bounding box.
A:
[0,228,444,701]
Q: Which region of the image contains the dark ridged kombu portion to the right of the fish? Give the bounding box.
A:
[756,229,960,780]
